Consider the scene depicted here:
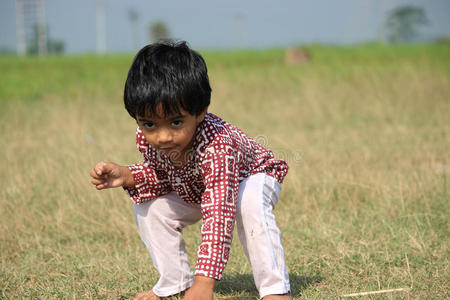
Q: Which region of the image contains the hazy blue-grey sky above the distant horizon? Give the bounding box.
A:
[0,0,450,53]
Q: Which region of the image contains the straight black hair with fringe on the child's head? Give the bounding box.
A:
[124,40,211,119]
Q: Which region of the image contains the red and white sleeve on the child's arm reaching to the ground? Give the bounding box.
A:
[195,147,239,280]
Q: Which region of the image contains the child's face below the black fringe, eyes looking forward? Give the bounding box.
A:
[136,107,206,163]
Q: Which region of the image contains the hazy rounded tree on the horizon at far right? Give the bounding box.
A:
[386,5,429,43]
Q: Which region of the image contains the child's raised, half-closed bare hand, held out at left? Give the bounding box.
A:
[90,161,135,190]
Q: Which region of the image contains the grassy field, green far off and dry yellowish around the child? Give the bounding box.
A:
[0,44,450,299]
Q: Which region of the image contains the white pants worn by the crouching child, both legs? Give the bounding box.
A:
[133,173,290,298]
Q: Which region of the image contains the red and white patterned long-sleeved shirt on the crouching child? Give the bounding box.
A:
[125,113,288,280]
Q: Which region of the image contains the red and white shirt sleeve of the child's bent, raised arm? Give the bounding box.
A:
[124,128,171,204]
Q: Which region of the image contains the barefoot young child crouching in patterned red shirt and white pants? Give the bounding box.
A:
[91,41,291,300]
